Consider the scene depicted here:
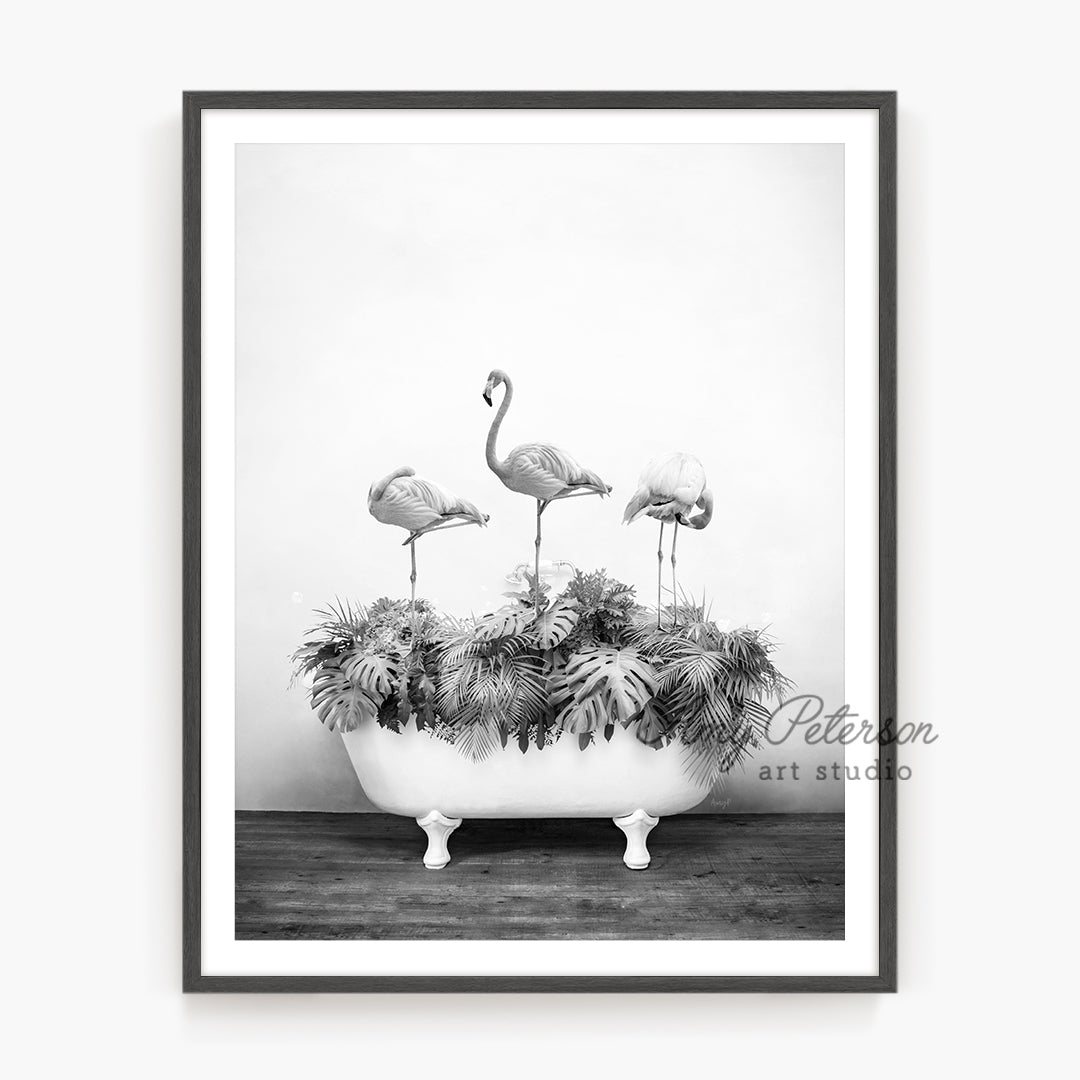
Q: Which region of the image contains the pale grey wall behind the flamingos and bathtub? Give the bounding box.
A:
[237,145,843,811]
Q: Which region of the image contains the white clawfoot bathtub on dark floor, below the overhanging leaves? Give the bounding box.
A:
[341,723,707,870]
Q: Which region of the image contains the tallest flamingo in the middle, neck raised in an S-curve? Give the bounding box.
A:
[484,368,611,616]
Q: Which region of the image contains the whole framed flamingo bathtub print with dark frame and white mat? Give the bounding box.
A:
[184,92,903,993]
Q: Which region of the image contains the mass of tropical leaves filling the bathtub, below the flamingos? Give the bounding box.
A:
[293,569,789,786]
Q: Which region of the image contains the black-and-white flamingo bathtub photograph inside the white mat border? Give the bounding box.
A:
[235,137,845,940]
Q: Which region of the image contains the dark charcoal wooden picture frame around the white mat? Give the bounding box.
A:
[183,91,896,994]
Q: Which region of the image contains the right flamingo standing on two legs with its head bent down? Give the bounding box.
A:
[622,450,713,630]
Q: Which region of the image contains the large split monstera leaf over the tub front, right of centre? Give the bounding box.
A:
[551,648,659,741]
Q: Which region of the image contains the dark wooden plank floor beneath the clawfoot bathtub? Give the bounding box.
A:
[235,811,843,940]
